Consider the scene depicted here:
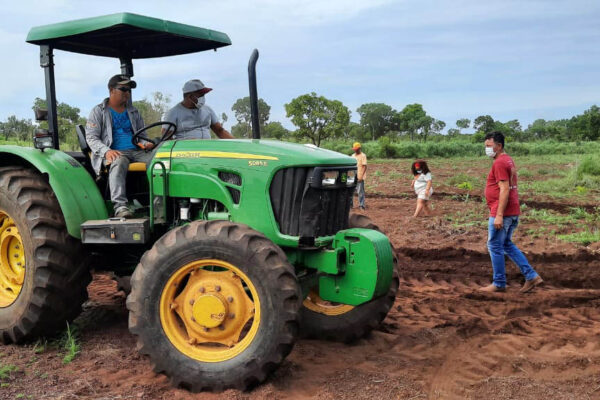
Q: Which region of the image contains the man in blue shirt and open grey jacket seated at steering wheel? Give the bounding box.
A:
[85,75,154,218]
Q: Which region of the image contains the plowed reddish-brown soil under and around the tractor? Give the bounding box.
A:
[0,167,600,400]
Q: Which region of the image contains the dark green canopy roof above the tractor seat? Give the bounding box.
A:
[27,13,231,59]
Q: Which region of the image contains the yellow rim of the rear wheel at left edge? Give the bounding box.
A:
[0,210,25,307]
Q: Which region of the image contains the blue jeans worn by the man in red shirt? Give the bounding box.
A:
[488,215,538,288]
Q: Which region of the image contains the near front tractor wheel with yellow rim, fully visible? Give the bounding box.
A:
[127,221,302,392]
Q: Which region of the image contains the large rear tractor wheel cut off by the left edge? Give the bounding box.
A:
[0,167,91,344]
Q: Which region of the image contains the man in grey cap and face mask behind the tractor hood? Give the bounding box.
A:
[163,79,234,139]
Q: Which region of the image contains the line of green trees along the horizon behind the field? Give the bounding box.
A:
[0,92,600,148]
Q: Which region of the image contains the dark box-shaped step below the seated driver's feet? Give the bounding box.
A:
[81,218,150,244]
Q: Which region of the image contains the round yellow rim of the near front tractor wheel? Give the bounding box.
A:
[160,259,260,362]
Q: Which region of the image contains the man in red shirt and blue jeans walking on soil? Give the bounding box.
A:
[480,132,544,293]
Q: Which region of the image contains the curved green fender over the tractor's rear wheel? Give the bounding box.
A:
[0,145,108,239]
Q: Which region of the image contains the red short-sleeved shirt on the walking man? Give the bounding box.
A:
[485,153,521,217]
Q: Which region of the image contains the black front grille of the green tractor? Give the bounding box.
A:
[270,167,356,239]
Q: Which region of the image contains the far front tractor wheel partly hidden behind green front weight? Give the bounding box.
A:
[300,214,400,343]
